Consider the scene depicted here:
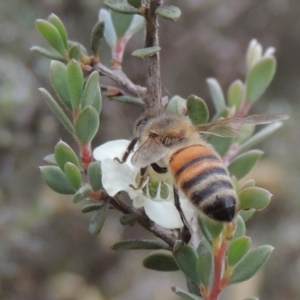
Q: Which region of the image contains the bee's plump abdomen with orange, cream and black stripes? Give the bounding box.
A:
[170,144,236,222]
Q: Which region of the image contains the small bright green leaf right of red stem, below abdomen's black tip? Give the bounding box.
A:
[227,236,251,266]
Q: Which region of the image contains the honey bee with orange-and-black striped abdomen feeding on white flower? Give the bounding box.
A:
[119,114,288,230]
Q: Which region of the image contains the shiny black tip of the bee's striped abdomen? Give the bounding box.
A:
[205,196,236,222]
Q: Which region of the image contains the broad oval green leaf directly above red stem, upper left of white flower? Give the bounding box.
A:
[75,106,99,145]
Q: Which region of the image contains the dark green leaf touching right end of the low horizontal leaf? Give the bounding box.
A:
[175,245,199,284]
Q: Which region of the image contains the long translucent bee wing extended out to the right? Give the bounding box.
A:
[196,114,289,137]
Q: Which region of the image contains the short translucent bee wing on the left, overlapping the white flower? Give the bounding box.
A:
[131,138,169,168]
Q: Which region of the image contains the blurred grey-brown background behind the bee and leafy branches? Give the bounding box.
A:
[0,0,300,300]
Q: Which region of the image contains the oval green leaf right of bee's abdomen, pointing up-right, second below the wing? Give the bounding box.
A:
[228,150,263,180]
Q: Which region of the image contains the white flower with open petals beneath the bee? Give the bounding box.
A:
[93,140,194,229]
